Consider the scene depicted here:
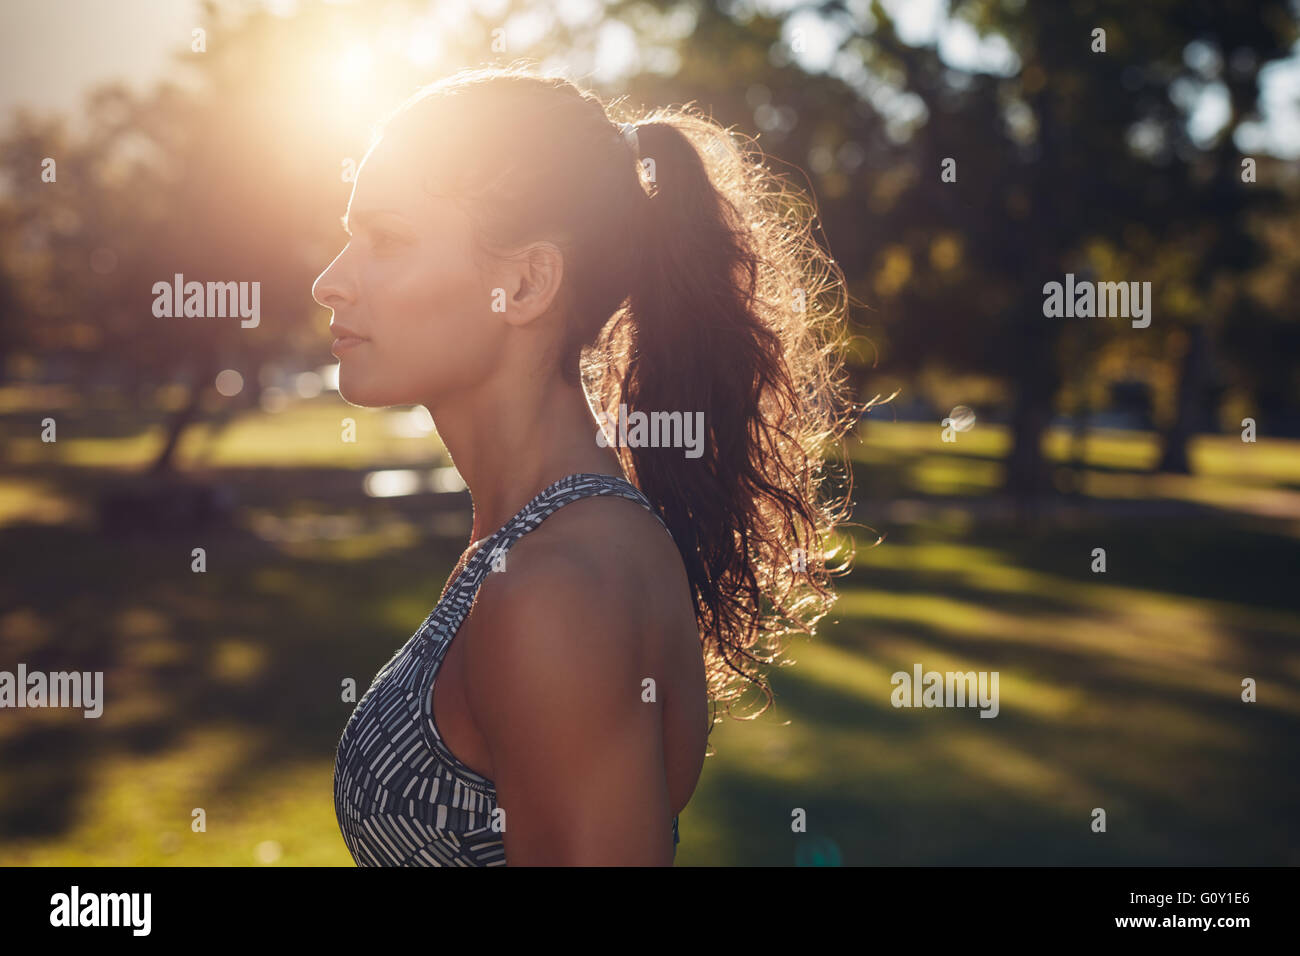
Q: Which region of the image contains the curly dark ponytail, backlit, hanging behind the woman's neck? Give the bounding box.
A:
[585,109,857,715]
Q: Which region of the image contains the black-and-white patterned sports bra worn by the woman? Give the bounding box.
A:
[334,472,680,866]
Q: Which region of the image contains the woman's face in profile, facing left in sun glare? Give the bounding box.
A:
[312,133,506,406]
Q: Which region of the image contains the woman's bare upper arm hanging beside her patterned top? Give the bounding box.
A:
[465,541,672,866]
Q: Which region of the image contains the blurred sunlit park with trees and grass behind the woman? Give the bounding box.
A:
[0,0,1300,865]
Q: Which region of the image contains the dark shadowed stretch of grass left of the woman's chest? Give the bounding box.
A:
[0,481,464,842]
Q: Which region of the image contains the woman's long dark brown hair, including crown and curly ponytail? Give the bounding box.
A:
[377,65,859,738]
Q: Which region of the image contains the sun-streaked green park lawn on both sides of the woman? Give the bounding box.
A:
[0,390,1300,866]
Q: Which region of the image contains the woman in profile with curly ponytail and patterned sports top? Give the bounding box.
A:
[312,61,855,866]
